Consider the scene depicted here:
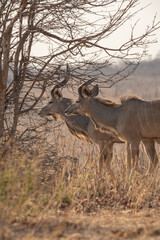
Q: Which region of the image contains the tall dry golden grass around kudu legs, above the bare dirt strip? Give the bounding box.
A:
[0,127,160,223]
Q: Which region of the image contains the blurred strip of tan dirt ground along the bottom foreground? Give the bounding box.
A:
[0,209,160,240]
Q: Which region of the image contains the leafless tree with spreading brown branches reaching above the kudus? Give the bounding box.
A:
[0,0,160,141]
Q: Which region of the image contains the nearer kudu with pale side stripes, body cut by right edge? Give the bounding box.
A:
[65,80,160,179]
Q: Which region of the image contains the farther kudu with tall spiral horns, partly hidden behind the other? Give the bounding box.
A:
[39,67,123,179]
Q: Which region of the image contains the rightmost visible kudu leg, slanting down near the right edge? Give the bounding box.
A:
[142,139,159,175]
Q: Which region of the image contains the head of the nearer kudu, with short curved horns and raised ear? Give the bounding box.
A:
[65,79,99,115]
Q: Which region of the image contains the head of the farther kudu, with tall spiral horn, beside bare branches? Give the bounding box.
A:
[38,64,71,120]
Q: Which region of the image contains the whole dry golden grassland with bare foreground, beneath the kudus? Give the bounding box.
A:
[0,71,160,240]
